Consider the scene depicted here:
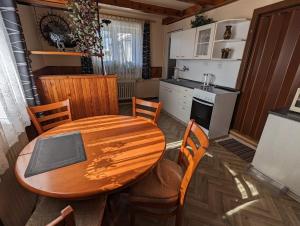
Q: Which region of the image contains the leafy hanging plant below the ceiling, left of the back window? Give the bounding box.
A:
[67,0,110,74]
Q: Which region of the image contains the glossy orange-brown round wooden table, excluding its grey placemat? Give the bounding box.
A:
[15,115,165,199]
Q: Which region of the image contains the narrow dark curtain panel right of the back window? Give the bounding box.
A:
[142,22,151,79]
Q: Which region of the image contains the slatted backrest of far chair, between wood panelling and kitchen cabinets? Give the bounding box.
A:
[132,97,161,124]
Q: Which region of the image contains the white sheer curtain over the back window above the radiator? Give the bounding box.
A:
[93,19,143,79]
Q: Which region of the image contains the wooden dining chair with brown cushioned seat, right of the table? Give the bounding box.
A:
[129,120,209,226]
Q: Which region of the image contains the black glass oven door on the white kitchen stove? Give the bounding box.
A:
[191,97,214,130]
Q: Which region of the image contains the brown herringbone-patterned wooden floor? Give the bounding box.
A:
[105,105,300,226]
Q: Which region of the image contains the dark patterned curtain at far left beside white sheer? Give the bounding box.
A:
[0,0,40,106]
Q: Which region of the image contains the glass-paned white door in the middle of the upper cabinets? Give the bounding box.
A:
[194,23,215,59]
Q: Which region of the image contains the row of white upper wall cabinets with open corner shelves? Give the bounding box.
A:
[170,19,250,61]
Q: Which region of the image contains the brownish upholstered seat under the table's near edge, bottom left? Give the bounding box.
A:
[26,195,106,226]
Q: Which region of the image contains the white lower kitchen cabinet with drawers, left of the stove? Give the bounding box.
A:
[159,81,193,123]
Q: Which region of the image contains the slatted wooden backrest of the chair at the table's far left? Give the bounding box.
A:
[27,99,72,134]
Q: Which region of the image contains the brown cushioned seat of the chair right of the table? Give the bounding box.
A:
[129,159,183,204]
